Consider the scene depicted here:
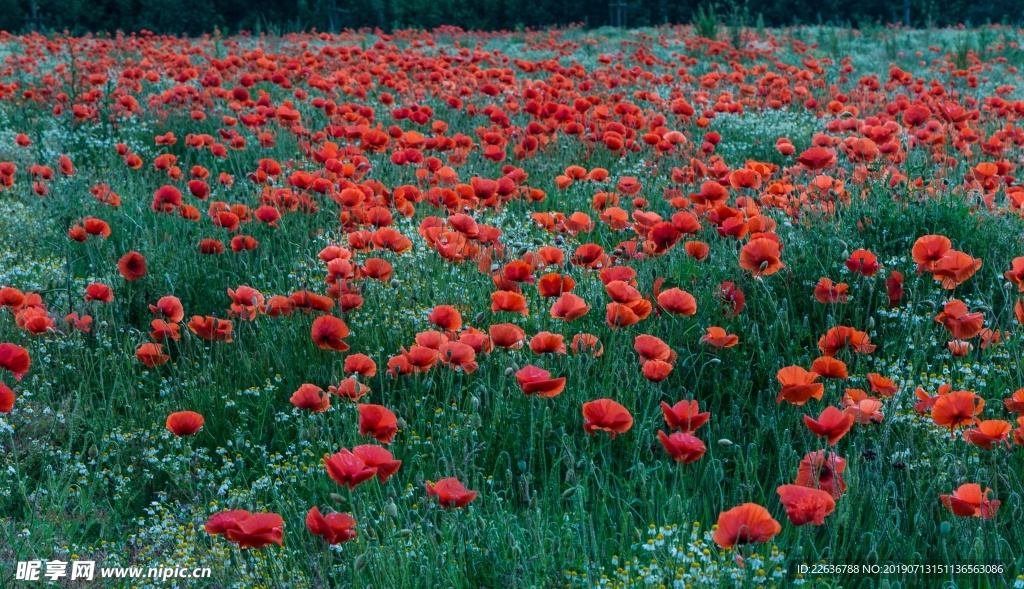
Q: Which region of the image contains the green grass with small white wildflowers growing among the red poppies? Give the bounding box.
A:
[0,23,1024,589]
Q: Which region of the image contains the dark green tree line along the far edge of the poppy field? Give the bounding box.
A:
[0,0,1024,35]
